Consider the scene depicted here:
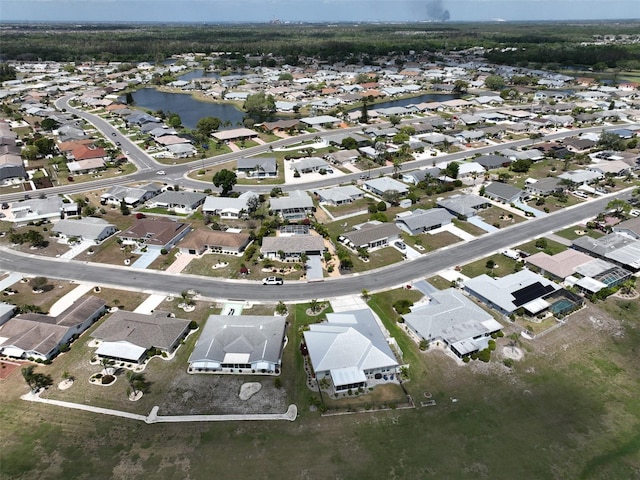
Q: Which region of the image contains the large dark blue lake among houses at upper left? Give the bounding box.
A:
[126,88,244,130]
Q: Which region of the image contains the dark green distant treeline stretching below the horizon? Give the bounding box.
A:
[0,22,640,68]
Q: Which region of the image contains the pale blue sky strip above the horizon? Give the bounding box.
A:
[0,0,640,23]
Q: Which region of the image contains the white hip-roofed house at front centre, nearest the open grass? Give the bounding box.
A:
[304,309,399,392]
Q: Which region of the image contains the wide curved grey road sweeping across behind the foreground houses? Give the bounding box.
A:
[0,188,633,302]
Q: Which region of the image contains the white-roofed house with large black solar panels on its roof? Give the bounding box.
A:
[464,269,560,315]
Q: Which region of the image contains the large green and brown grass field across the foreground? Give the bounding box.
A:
[0,290,640,480]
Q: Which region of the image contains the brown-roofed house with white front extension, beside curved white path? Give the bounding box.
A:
[91,310,191,364]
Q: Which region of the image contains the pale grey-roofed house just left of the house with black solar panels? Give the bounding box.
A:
[403,288,502,358]
